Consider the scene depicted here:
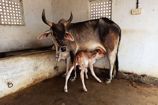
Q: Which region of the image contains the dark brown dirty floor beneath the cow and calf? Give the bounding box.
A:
[0,76,158,105]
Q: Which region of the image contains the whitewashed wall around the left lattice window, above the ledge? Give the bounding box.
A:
[0,0,53,52]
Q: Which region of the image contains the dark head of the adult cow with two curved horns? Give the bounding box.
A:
[42,10,73,46]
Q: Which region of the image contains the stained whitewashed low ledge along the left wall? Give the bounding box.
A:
[0,51,65,98]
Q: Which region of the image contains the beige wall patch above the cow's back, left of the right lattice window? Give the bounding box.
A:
[52,0,89,22]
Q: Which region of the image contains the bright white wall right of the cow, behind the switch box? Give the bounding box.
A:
[113,0,158,77]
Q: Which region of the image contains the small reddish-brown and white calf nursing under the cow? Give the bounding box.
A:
[64,48,105,92]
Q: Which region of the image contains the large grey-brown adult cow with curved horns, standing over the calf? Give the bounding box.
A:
[42,10,121,83]
